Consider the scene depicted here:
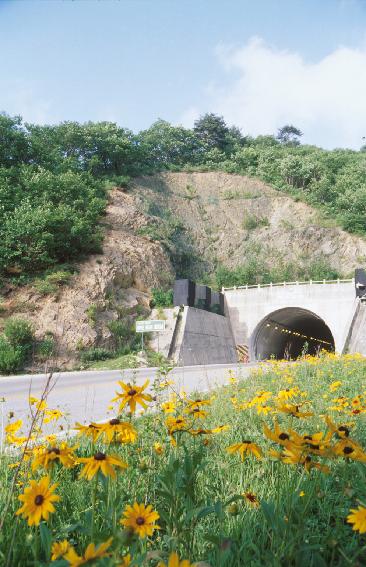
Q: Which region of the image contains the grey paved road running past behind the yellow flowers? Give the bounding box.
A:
[0,363,256,440]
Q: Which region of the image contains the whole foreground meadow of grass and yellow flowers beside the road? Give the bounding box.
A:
[0,354,366,567]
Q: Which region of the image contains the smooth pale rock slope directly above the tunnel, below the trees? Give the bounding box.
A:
[135,172,366,283]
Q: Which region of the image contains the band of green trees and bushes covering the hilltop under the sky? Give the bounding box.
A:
[0,110,366,274]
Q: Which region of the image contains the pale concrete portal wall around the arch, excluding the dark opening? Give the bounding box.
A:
[225,282,357,358]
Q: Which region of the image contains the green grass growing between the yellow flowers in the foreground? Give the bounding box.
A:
[0,355,366,567]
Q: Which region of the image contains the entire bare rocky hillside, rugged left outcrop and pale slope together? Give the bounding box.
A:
[0,173,366,369]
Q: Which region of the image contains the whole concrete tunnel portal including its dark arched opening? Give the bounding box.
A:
[224,280,357,361]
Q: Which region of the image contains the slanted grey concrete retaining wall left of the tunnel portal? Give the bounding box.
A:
[171,307,237,366]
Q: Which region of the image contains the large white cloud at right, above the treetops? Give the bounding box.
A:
[182,38,366,148]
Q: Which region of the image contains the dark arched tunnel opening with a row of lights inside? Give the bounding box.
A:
[249,307,334,360]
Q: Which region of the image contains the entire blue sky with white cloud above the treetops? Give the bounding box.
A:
[0,0,366,149]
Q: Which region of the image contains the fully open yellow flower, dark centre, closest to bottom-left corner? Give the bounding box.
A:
[16,476,60,526]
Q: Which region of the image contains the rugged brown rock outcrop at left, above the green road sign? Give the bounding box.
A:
[1,190,173,367]
